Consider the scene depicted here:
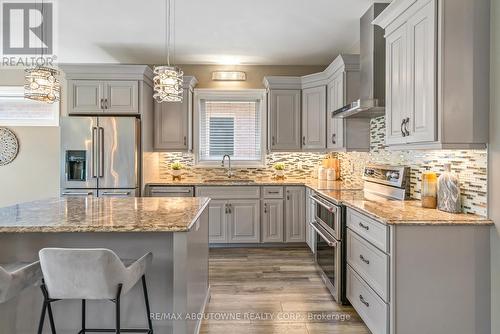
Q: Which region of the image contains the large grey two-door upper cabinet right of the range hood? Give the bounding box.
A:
[374,0,490,149]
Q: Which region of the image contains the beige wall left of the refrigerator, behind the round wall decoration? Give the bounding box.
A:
[0,69,59,206]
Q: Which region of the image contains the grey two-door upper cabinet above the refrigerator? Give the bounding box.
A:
[61,65,152,115]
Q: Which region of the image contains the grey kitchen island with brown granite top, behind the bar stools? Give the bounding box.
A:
[0,197,210,334]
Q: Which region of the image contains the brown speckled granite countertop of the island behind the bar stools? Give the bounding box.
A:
[0,197,210,233]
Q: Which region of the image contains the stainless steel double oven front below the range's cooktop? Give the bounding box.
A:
[310,193,348,304]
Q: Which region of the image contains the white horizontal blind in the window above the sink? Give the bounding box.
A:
[198,99,262,162]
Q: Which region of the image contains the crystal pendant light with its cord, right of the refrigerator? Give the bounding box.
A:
[153,0,184,103]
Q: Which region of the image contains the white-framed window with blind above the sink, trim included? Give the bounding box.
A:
[195,89,265,167]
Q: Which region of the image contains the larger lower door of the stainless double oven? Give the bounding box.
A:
[310,223,342,303]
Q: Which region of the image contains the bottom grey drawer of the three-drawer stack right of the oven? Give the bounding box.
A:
[346,265,389,334]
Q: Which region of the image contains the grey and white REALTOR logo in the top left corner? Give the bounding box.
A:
[0,0,55,66]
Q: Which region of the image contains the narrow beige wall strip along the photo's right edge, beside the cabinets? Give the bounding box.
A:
[488,1,500,333]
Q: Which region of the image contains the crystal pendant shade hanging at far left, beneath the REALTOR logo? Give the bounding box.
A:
[24,66,61,103]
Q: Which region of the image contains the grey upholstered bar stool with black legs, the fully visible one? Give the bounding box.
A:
[38,248,153,334]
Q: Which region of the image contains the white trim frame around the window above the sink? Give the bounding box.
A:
[193,88,267,168]
